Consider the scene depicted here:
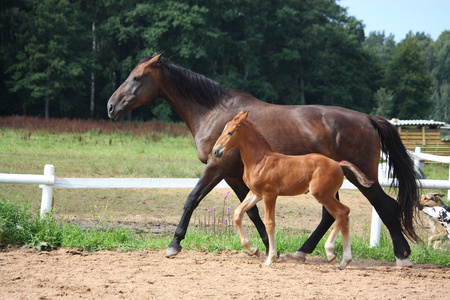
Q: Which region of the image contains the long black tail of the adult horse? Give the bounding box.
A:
[370,116,420,241]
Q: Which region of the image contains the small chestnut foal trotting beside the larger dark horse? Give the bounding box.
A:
[213,111,373,270]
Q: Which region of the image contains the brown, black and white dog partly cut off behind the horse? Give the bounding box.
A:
[419,193,450,249]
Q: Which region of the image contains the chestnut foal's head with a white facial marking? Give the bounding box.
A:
[213,111,248,158]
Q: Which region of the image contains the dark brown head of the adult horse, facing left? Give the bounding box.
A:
[107,54,161,121]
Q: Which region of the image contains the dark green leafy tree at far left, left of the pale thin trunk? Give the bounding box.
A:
[7,0,89,119]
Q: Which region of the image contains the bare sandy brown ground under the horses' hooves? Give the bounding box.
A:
[0,249,450,299]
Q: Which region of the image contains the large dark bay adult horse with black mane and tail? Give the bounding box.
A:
[107,54,420,266]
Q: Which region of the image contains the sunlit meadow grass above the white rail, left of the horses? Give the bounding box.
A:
[0,129,203,177]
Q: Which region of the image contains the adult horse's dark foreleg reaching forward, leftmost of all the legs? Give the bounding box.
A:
[166,164,223,258]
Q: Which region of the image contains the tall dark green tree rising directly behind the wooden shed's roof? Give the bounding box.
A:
[385,36,432,119]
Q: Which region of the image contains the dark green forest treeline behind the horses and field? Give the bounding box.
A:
[0,0,450,121]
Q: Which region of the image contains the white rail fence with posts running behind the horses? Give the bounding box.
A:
[0,147,450,247]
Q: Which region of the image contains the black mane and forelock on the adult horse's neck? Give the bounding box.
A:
[138,57,227,108]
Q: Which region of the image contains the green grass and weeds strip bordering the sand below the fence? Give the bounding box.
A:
[0,199,450,267]
